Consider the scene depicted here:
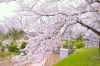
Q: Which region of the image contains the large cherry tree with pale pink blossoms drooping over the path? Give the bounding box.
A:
[0,0,100,66]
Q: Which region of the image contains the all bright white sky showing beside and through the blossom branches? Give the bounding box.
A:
[0,0,86,24]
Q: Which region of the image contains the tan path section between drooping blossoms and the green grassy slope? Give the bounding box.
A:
[44,54,60,66]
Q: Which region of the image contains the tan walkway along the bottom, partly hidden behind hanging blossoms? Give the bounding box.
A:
[0,54,60,66]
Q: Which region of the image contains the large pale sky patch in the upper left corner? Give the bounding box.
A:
[0,1,18,24]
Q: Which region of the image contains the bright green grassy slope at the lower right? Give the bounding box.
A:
[53,48,100,66]
